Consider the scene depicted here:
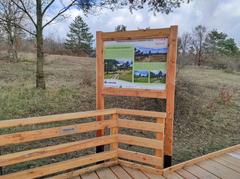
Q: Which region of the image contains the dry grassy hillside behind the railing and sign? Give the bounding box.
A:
[0,54,240,170]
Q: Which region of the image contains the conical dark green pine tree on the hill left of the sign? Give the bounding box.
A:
[65,16,93,55]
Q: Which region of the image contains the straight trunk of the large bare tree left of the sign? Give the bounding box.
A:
[36,0,46,89]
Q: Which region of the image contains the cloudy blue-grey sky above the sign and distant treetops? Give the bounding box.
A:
[46,0,240,46]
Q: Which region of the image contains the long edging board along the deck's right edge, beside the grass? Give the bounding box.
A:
[164,144,240,173]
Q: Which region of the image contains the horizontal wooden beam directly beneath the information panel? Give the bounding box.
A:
[103,88,166,99]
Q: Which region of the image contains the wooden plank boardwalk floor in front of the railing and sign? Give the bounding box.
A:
[71,145,240,179]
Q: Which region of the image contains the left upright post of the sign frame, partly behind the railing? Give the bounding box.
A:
[96,32,104,153]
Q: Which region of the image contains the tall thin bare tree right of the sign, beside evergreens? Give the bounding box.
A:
[192,25,208,66]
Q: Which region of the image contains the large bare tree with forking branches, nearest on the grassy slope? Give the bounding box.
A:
[3,0,77,89]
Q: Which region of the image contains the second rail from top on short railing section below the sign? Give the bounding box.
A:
[118,119,164,132]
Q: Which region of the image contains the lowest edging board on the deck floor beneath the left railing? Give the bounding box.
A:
[48,161,117,179]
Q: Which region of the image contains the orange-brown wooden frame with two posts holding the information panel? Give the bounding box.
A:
[96,26,178,167]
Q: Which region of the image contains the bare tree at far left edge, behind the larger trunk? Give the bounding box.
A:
[0,0,24,62]
